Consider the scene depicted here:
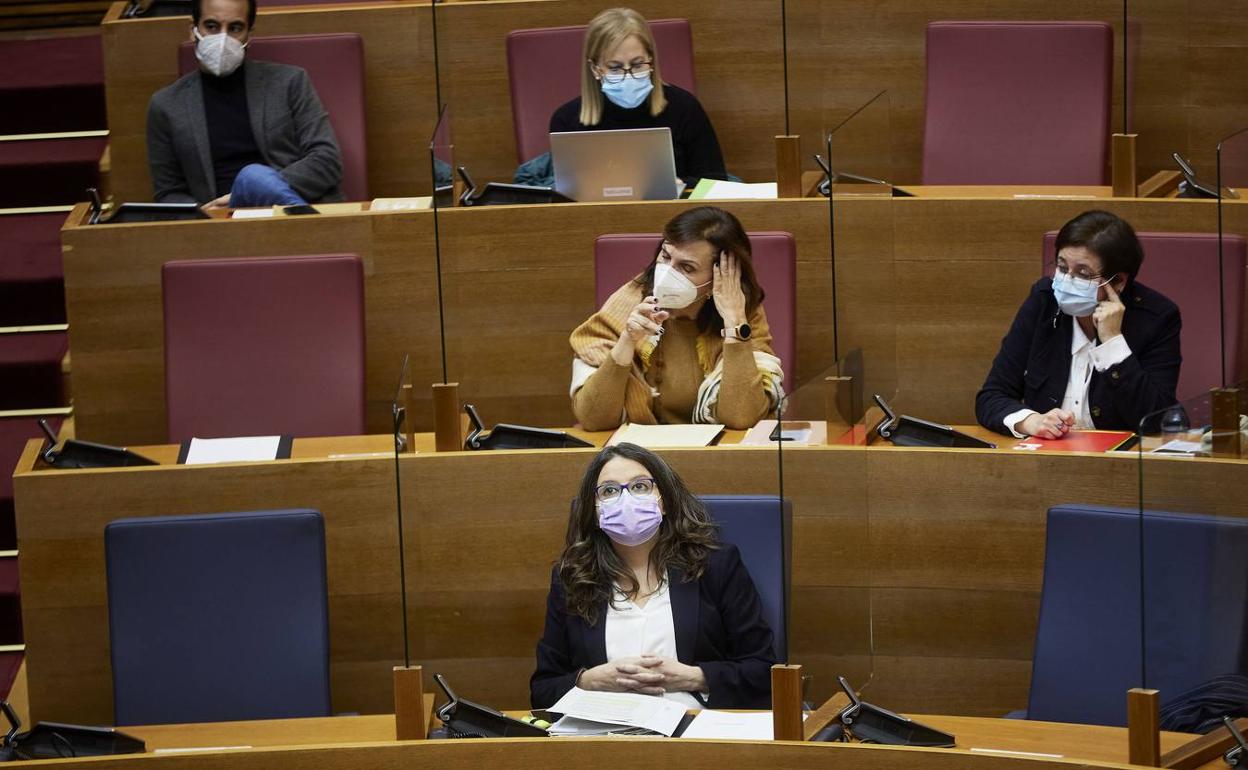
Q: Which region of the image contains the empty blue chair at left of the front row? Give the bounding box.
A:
[104,509,331,725]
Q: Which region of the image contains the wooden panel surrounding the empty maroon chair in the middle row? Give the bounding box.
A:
[62,206,442,446]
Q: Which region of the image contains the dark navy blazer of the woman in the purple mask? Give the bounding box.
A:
[529,543,776,709]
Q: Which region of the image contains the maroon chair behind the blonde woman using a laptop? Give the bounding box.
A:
[507,19,698,162]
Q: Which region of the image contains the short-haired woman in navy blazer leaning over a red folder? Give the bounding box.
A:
[975,211,1182,438]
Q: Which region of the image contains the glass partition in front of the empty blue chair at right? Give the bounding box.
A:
[1134,381,1248,718]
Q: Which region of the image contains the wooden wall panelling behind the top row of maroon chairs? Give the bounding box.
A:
[102,0,1248,200]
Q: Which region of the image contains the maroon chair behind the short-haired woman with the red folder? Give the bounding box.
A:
[1043,232,1248,399]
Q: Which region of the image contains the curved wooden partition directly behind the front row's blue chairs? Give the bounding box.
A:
[14,437,1248,724]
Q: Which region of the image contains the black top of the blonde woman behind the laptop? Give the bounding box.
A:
[550,84,728,187]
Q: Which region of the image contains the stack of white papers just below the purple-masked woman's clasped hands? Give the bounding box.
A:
[550,688,685,738]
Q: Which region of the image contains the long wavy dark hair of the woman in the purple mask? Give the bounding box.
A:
[557,443,719,625]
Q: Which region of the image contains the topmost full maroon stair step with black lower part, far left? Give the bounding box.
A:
[0,32,107,134]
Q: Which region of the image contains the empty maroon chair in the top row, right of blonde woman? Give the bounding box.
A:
[924,21,1113,185]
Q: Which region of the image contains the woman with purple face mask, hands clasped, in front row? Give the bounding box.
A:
[529,443,775,709]
